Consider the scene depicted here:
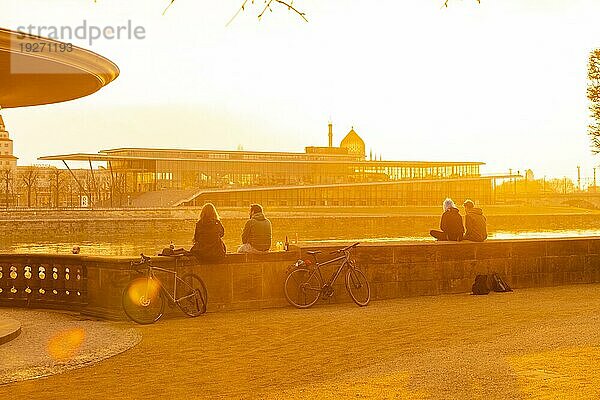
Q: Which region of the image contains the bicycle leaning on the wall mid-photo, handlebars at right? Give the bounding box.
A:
[284,243,371,308]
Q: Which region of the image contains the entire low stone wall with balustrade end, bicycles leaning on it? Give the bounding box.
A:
[0,237,600,319]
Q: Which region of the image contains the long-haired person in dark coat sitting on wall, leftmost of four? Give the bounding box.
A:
[190,203,227,262]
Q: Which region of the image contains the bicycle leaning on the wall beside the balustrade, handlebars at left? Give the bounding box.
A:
[122,254,208,325]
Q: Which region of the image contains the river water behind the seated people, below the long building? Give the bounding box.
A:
[0,214,600,256]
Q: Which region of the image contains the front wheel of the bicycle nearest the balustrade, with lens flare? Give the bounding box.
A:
[121,278,165,325]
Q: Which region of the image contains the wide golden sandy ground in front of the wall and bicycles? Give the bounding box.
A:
[0,285,600,399]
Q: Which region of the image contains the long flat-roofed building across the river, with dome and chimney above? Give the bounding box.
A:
[41,126,495,206]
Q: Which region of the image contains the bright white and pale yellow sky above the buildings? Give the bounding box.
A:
[0,0,600,183]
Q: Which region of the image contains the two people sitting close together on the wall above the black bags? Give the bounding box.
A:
[429,199,487,242]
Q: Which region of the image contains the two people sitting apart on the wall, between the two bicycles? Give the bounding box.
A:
[190,203,271,262]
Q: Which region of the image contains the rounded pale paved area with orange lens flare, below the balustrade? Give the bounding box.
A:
[0,309,141,385]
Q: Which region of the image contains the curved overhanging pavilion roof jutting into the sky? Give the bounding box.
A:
[0,28,119,108]
